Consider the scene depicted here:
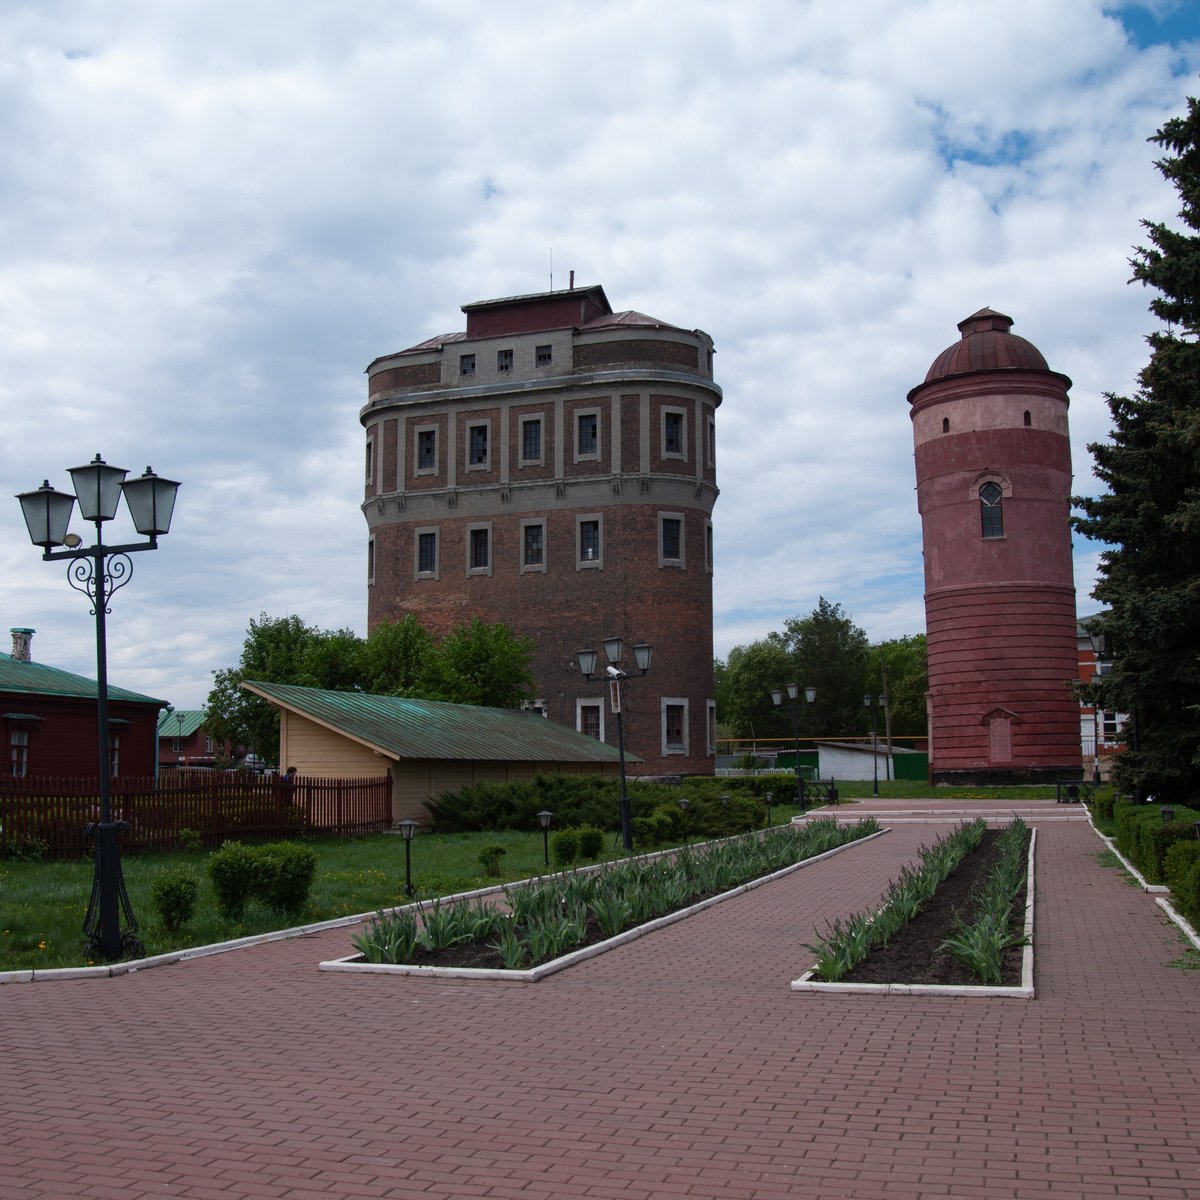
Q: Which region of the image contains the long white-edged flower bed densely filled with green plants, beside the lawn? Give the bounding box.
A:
[322,820,878,979]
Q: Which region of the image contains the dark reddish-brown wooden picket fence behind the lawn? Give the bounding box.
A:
[0,768,391,858]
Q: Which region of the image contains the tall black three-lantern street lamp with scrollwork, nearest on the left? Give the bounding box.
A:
[17,455,179,961]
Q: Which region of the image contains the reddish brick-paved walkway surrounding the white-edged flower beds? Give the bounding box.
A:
[0,802,1200,1200]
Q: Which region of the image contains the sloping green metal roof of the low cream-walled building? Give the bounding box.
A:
[242,679,641,763]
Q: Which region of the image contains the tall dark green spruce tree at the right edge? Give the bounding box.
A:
[1074,98,1200,803]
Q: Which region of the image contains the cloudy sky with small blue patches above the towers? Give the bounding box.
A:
[0,0,1200,707]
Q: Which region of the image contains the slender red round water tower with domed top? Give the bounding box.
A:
[908,308,1080,784]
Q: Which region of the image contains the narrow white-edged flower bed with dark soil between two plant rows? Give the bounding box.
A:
[792,821,1033,995]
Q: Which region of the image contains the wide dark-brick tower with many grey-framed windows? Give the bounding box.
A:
[360,286,721,775]
